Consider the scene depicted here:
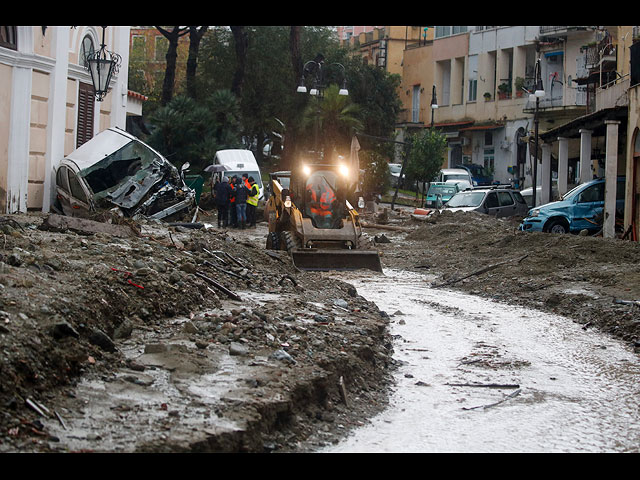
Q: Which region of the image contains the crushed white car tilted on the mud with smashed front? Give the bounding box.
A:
[54,128,196,220]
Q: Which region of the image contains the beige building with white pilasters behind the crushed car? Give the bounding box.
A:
[0,26,132,213]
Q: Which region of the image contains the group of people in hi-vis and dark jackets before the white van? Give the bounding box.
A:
[213,173,260,228]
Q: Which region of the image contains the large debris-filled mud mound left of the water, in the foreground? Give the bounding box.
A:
[0,215,393,452]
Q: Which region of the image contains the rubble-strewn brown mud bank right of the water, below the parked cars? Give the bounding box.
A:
[377,211,640,346]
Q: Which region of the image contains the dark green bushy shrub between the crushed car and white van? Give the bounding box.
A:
[147,90,241,172]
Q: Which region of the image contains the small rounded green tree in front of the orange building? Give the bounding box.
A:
[405,128,447,183]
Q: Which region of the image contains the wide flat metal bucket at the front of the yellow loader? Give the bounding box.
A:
[291,248,382,272]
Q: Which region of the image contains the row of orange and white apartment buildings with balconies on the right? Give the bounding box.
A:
[397,26,640,240]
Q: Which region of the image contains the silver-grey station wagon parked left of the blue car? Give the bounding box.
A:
[444,185,527,217]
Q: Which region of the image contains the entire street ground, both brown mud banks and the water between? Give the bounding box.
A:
[0,209,640,452]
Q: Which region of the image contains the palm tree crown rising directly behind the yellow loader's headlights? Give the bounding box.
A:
[302,85,363,158]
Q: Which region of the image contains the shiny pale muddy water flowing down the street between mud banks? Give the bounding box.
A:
[322,270,640,453]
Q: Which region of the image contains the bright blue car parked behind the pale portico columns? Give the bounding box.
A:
[520,177,625,233]
